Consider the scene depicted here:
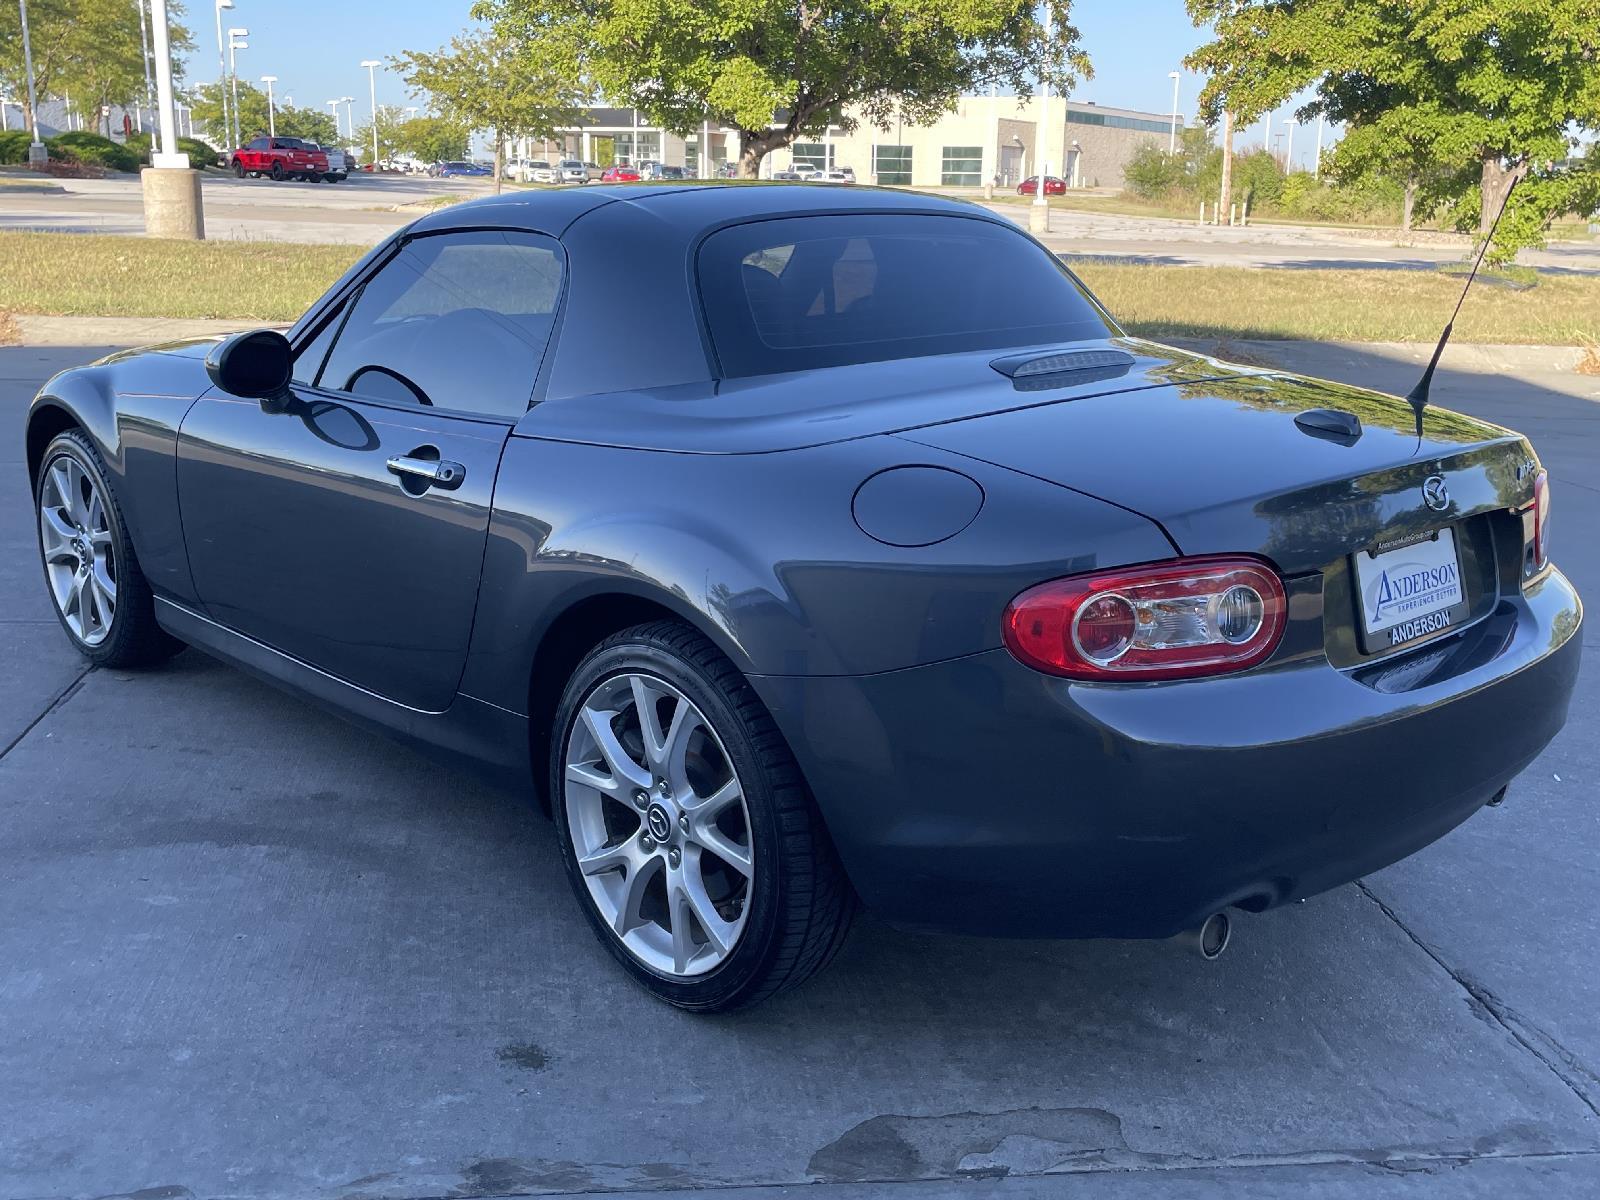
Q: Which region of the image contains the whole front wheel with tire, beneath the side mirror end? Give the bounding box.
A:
[34,429,182,667]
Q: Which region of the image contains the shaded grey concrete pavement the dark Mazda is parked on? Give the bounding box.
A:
[0,340,1600,1200]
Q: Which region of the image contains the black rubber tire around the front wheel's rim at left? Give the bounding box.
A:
[34,429,184,667]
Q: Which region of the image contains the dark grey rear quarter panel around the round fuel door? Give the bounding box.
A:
[462,437,1173,712]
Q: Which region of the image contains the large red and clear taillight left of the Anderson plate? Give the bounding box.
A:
[1003,555,1285,682]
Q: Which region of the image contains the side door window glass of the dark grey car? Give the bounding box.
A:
[316,230,563,419]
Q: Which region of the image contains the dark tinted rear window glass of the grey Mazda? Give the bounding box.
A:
[698,214,1110,378]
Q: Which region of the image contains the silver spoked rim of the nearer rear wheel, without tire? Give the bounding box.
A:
[563,674,755,979]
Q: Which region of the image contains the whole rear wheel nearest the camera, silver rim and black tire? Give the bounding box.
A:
[550,621,854,1011]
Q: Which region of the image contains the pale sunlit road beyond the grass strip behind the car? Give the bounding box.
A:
[0,173,1600,275]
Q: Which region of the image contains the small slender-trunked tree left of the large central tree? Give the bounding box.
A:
[389,34,581,192]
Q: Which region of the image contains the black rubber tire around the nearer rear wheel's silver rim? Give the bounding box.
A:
[549,621,856,1013]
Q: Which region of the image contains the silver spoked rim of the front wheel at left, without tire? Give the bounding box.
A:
[38,454,117,646]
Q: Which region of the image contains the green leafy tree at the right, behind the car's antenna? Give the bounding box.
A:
[1187,0,1600,261]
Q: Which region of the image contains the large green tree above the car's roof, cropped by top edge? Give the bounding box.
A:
[474,0,1090,178]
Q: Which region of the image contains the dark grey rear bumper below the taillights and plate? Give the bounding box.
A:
[750,573,1582,938]
